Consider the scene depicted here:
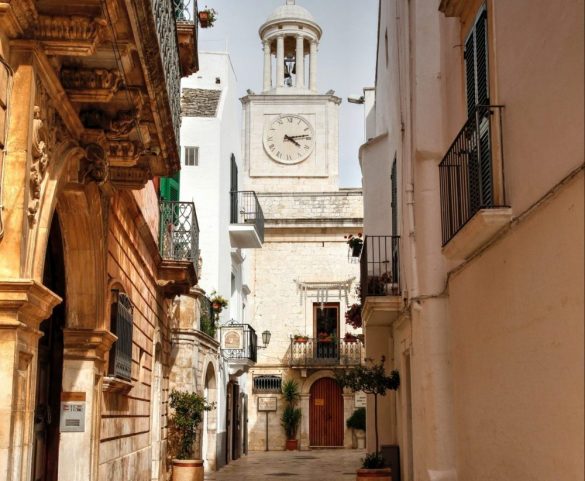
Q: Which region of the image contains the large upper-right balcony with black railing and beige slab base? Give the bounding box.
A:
[439,105,512,259]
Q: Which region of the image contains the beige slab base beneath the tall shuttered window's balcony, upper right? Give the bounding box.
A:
[443,207,512,260]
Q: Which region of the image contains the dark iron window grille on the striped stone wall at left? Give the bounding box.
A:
[108,291,134,381]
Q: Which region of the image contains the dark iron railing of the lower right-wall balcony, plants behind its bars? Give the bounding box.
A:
[360,235,400,304]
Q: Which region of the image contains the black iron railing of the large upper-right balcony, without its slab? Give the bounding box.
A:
[439,105,505,245]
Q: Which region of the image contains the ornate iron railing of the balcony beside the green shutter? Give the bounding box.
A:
[159,200,199,270]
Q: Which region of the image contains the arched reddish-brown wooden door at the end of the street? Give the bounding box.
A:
[309,377,343,447]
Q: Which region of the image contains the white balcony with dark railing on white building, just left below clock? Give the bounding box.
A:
[229,192,264,249]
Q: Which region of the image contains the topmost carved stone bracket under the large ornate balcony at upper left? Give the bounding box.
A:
[35,15,107,56]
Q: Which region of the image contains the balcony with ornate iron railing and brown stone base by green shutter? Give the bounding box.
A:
[159,201,199,296]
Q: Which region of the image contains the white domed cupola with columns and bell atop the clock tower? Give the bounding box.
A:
[258,0,323,95]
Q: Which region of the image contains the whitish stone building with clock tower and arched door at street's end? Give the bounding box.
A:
[241,0,363,450]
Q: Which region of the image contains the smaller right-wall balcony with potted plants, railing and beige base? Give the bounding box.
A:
[360,235,402,326]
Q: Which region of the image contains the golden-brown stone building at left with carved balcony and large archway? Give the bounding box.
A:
[0,0,198,481]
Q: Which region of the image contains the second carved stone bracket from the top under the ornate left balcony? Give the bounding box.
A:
[61,68,122,103]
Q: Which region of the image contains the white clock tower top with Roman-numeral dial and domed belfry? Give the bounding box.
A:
[242,0,341,192]
